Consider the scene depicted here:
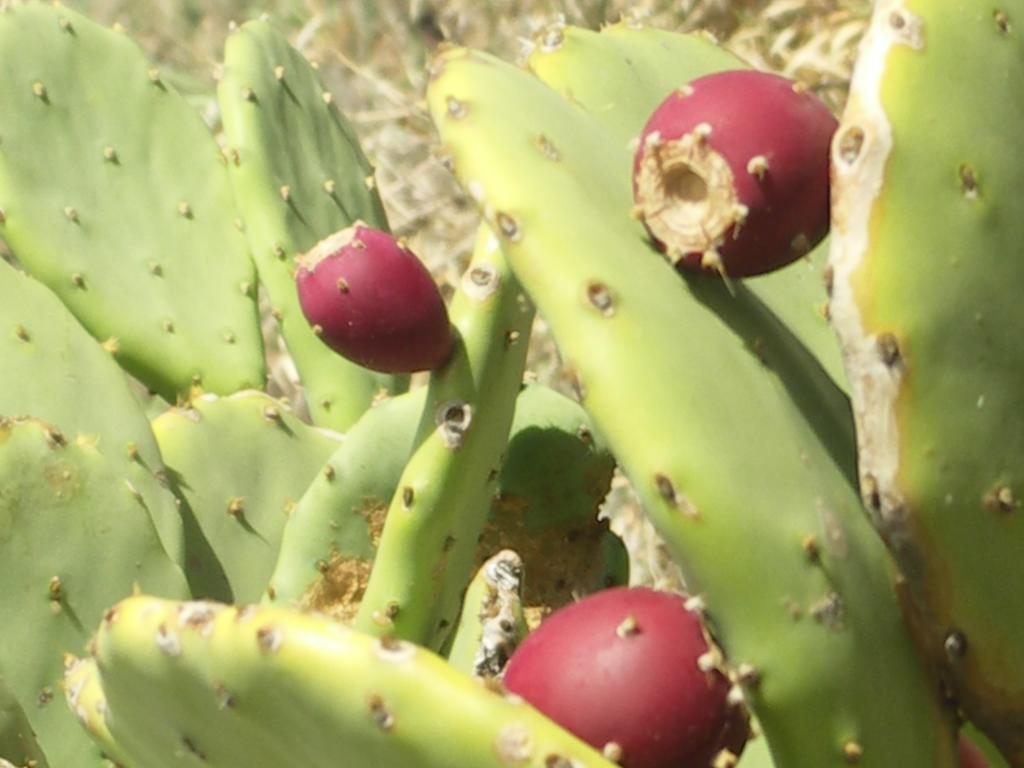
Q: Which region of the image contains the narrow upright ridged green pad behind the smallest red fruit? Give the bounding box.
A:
[218,20,403,430]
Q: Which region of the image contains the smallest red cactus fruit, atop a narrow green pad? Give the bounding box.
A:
[295,221,454,373]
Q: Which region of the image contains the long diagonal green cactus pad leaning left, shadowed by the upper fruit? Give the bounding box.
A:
[427,49,956,768]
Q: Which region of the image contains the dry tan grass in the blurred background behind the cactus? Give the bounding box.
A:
[58,0,870,588]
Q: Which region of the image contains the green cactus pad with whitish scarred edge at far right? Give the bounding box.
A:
[831,0,1024,765]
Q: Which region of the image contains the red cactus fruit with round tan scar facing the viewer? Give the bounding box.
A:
[633,70,839,278]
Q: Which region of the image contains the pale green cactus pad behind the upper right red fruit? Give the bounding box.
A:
[526,23,847,397]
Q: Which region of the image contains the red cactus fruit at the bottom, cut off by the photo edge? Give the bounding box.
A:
[504,587,748,768]
